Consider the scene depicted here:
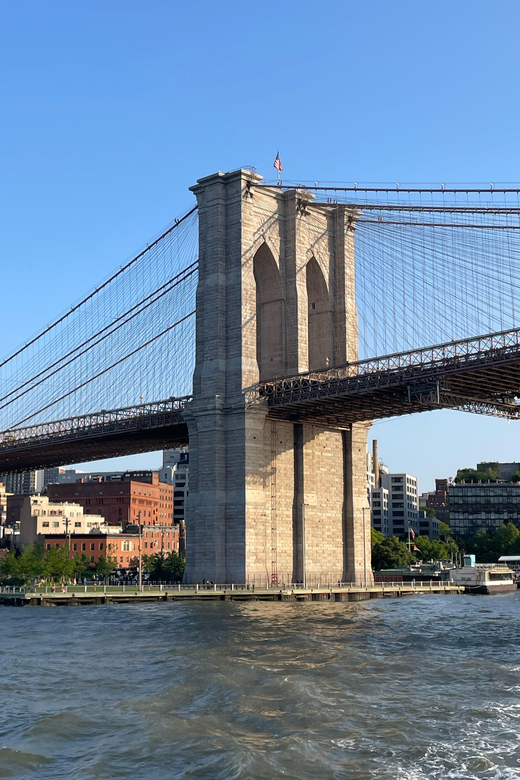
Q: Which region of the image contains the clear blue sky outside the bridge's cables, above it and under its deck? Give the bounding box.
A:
[0,0,520,489]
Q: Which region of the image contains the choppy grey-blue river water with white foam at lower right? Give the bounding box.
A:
[0,592,520,780]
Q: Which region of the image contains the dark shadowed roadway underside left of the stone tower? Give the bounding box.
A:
[0,422,188,475]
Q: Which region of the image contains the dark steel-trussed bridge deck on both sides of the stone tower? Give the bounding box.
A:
[0,329,520,474]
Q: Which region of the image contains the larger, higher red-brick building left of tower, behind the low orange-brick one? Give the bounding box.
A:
[47,471,174,529]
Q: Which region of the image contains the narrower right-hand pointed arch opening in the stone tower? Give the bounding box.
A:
[306,257,333,371]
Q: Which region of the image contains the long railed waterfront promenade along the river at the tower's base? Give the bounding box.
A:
[0,581,464,607]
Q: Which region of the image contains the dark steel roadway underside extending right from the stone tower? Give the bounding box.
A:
[260,346,520,427]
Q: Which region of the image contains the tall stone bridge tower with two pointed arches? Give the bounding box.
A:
[186,170,372,586]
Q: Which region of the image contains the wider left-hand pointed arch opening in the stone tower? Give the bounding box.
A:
[253,243,285,380]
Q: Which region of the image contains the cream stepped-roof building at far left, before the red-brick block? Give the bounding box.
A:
[16,496,116,548]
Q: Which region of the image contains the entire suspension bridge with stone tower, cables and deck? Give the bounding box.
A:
[0,169,520,584]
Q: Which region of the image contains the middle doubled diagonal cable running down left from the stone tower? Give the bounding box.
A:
[0,260,198,409]
